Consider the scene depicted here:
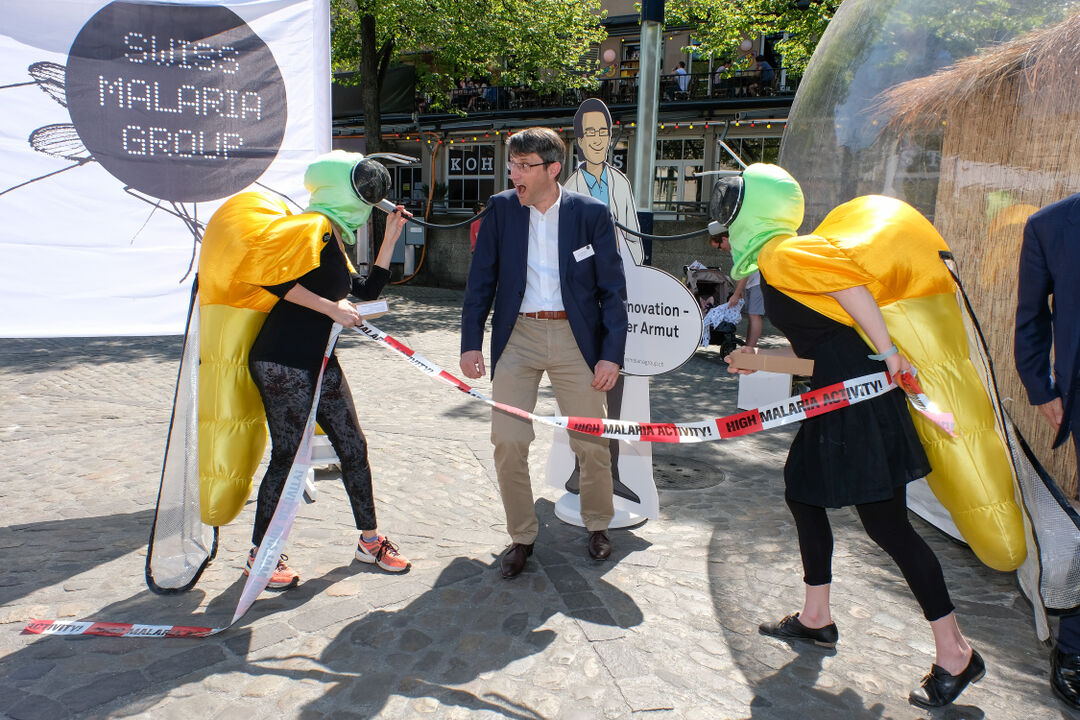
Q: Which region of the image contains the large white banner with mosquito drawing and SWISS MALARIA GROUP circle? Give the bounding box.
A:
[0,0,330,337]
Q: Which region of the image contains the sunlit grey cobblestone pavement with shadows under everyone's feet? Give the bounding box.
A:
[0,288,1069,720]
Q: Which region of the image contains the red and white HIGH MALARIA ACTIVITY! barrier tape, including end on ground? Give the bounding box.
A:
[24,323,955,638]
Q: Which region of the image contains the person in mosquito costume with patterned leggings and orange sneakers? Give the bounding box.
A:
[199,150,409,589]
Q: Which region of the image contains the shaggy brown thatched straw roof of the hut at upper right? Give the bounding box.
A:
[878,12,1080,128]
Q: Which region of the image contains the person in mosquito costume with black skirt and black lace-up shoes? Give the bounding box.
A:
[713,164,1025,708]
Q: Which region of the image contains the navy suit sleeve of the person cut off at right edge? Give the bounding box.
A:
[1013,215,1058,405]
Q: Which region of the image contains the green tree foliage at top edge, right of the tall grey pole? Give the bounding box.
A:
[665,0,841,71]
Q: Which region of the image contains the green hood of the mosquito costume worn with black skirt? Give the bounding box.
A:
[728,163,802,280]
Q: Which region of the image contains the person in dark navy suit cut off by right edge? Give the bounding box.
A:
[1013,193,1080,709]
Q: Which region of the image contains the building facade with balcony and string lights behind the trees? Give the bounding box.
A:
[333,0,797,286]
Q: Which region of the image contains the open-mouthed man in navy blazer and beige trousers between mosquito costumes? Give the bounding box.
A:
[461,127,626,578]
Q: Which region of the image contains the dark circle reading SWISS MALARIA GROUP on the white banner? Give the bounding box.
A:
[66,1,286,202]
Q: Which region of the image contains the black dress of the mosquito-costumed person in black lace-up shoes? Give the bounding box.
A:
[761,277,930,507]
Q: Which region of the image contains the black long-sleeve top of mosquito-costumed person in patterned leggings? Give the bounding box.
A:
[251,233,390,372]
